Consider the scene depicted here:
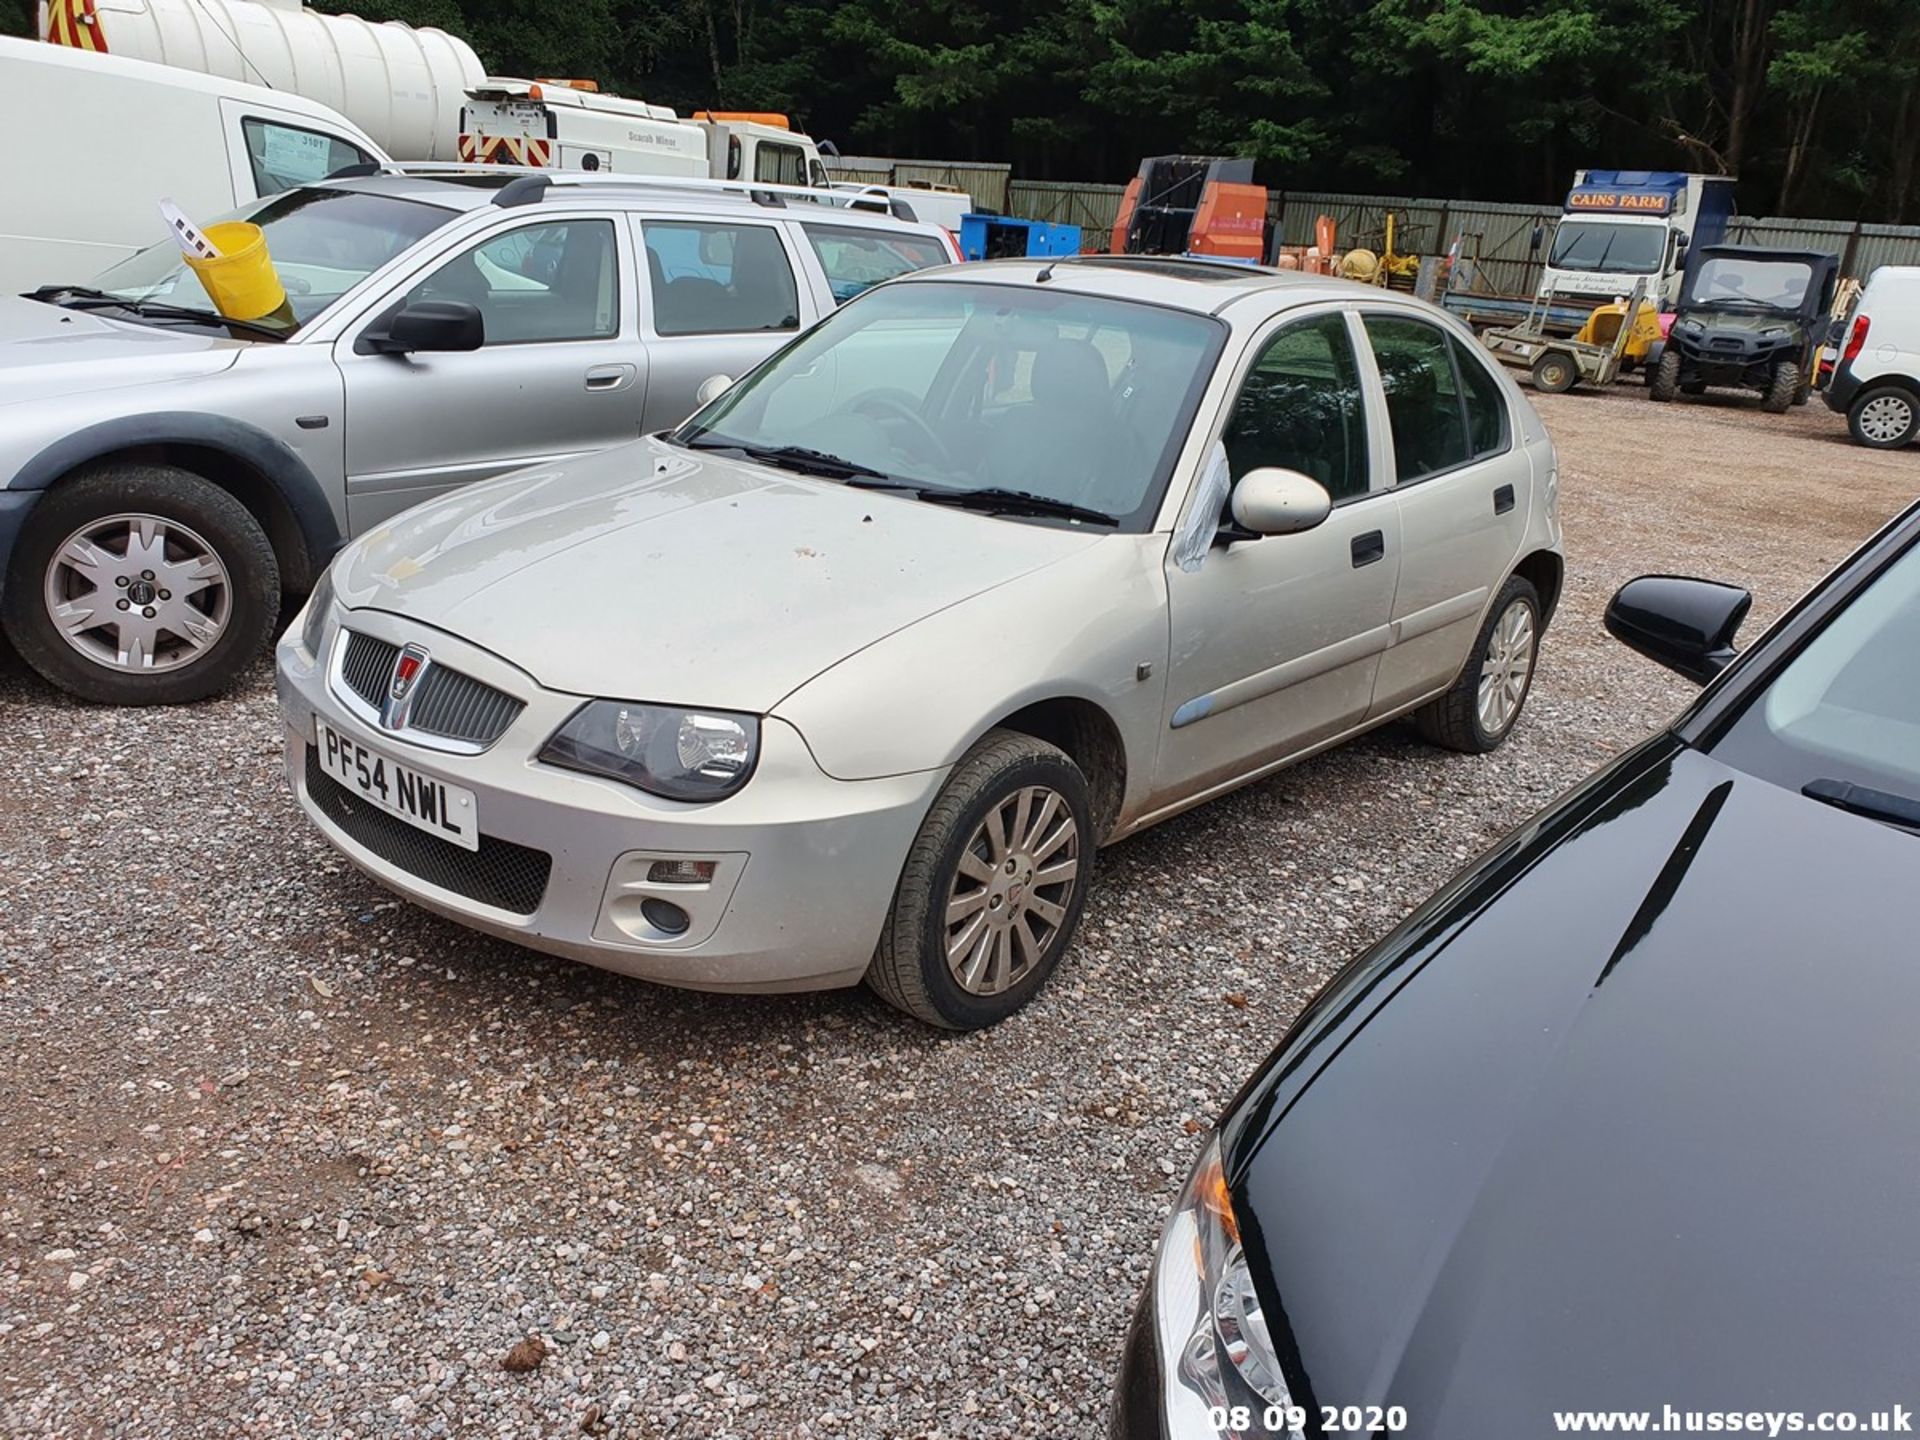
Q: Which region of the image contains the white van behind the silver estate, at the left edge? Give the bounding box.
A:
[0,36,386,294]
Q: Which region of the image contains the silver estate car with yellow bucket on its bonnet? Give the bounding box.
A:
[0,167,958,705]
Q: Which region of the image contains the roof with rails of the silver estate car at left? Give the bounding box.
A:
[319,165,960,234]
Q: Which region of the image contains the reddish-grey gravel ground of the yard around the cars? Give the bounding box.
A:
[0,386,1920,1440]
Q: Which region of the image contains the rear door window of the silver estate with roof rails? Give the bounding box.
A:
[641,221,801,336]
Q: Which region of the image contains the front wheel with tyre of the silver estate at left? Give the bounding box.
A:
[0,461,280,705]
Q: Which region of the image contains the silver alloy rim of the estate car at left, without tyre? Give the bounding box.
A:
[42,515,234,674]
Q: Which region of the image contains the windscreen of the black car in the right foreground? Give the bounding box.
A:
[1711,543,1920,804]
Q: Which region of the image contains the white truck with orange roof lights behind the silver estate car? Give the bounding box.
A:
[459,77,826,184]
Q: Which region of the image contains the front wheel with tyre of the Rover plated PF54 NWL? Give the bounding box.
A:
[866,730,1094,1031]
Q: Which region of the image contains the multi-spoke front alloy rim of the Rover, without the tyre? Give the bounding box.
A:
[943,785,1079,995]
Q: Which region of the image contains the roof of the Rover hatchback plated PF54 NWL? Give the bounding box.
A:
[893,255,1409,315]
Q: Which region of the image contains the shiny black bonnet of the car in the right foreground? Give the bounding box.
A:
[1225,741,1920,1438]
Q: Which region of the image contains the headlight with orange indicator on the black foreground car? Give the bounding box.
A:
[1154,1139,1308,1440]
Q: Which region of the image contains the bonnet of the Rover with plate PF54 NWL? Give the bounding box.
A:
[334,440,1098,710]
